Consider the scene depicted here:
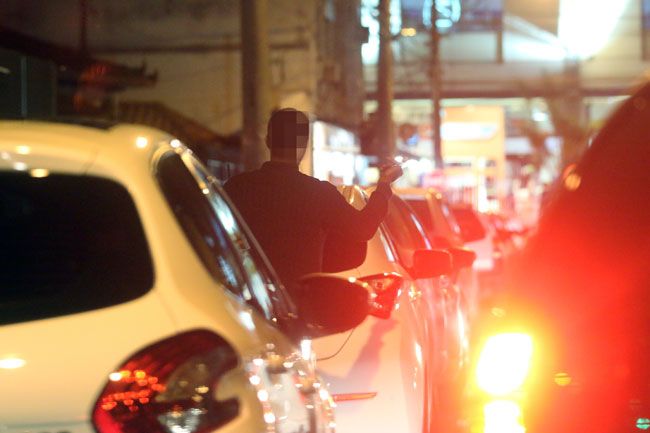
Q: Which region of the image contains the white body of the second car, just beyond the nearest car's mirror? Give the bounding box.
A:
[313,187,466,433]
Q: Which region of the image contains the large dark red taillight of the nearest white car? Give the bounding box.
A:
[93,330,239,433]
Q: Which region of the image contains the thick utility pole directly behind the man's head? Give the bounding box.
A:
[240,0,272,170]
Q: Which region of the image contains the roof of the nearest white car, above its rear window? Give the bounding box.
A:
[0,119,172,174]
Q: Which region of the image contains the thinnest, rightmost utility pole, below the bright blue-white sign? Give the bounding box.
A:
[431,0,444,170]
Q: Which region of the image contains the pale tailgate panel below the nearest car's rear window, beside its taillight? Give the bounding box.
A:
[0,292,175,432]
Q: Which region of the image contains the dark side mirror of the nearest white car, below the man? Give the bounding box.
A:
[292,274,370,338]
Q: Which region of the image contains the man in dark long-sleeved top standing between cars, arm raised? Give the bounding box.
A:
[224,108,402,289]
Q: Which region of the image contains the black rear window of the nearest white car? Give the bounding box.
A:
[0,172,154,324]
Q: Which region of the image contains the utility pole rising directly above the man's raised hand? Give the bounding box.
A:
[375,0,395,158]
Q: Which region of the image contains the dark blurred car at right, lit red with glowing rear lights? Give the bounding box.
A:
[467,85,650,433]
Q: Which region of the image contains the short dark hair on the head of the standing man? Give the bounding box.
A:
[266,108,309,149]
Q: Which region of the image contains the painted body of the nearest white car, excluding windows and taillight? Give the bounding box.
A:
[0,122,333,433]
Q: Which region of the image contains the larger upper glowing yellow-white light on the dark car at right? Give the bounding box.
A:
[476,333,533,396]
